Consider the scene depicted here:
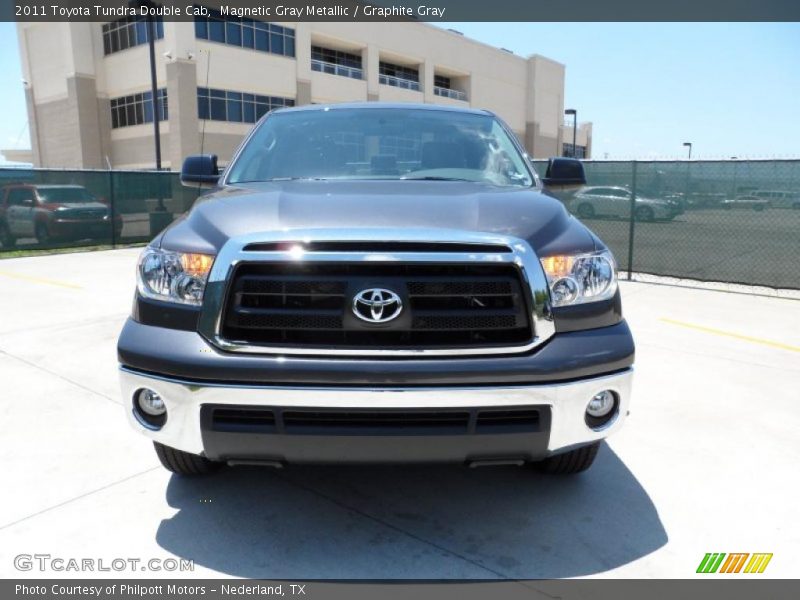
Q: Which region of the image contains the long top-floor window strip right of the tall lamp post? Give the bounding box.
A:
[194,9,295,56]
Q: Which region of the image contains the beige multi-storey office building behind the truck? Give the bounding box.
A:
[17,16,591,170]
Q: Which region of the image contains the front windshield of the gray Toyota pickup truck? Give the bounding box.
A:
[228,108,533,187]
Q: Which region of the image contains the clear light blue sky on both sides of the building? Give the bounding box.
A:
[0,23,800,163]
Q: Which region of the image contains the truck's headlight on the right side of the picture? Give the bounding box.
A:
[542,251,617,306]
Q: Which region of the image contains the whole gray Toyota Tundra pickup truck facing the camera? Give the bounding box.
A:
[118,103,634,475]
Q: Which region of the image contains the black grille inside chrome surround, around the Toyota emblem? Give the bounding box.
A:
[220,261,533,349]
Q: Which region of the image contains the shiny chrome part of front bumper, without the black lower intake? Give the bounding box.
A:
[120,367,633,460]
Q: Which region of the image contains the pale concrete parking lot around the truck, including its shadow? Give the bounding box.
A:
[0,247,800,579]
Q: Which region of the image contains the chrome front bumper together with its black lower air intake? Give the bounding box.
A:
[120,367,633,463]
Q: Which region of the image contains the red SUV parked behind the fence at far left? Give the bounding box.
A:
[0,183,122,248]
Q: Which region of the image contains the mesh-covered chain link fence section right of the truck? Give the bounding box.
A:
[536,160,800,289]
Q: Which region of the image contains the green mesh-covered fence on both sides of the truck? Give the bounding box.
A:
[0,160,800,289]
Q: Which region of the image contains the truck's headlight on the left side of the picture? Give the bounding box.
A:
[136,248,214,306]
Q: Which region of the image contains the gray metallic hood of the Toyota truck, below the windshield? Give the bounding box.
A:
[155,180,597,255]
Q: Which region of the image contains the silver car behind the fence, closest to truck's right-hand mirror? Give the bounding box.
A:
[569,186,683,221]
